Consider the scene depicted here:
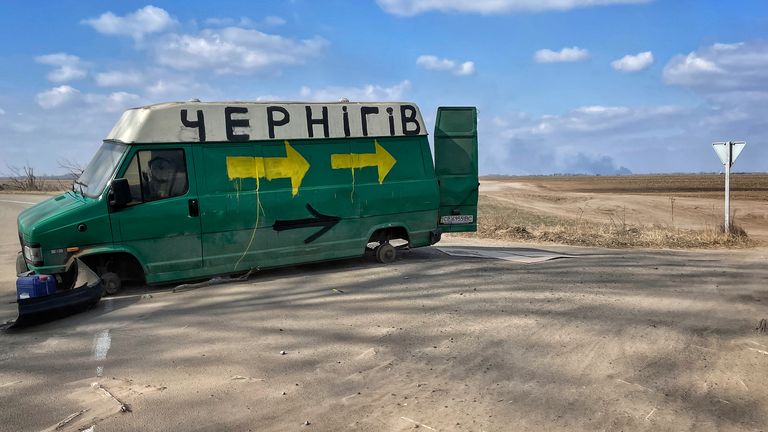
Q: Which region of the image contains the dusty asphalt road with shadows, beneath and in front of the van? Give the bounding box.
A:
[0,195,768,431]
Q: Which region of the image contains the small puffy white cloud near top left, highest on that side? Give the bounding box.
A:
[82,5,177,41]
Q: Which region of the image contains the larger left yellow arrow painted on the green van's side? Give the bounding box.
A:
[227,141,309,196]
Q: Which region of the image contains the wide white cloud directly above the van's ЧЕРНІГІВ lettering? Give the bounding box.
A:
[154,27,328,74]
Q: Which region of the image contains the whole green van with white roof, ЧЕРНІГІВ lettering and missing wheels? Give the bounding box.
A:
[18,101,478,293]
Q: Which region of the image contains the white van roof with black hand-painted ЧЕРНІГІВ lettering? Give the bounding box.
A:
[106,101,427,143]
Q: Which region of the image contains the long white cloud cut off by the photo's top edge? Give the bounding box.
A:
[376,0,653,16]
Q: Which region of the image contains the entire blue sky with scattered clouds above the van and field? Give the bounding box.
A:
[0,0,768,174]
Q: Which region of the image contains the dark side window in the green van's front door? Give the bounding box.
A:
[123,149,189,204]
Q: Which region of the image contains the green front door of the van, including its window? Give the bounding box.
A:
[110,145,202,283]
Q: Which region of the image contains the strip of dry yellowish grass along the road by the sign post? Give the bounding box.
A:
[468,195,757,249]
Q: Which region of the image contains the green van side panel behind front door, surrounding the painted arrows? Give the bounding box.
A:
[195,136,438,272]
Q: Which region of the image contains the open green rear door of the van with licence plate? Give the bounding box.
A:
[435,107,480,232]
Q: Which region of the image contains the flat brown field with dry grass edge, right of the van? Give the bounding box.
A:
[478,174,768,248]
